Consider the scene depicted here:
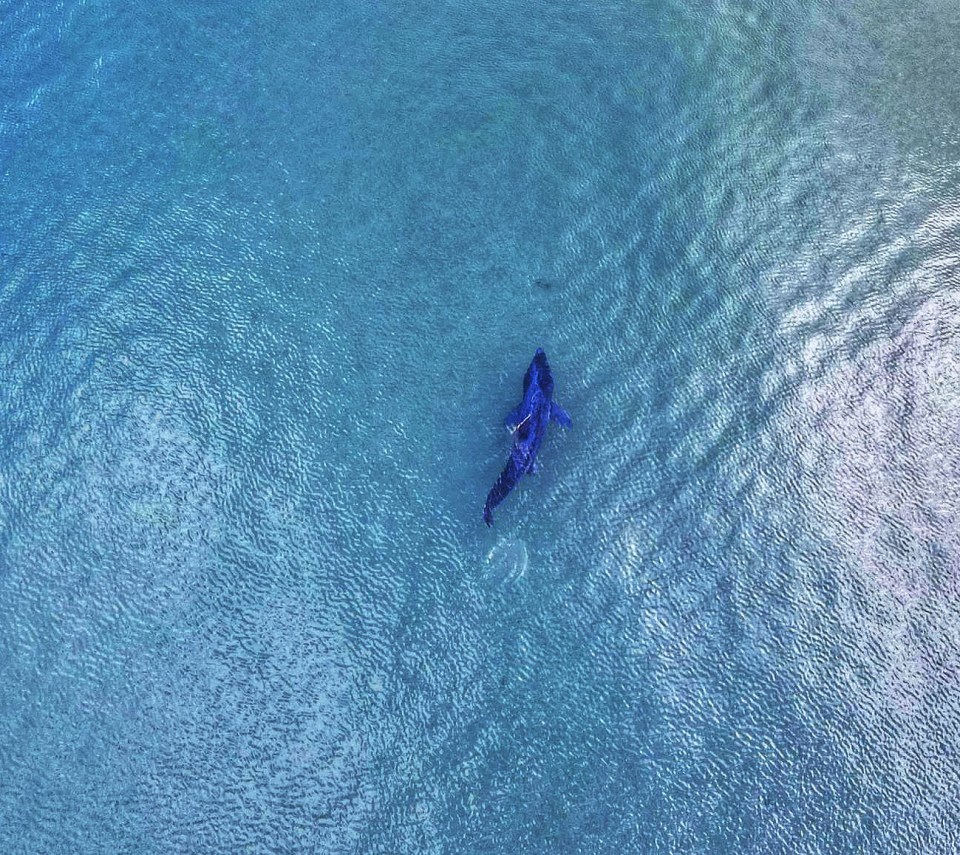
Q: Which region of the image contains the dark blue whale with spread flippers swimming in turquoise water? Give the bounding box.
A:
[483,347,571,525]
